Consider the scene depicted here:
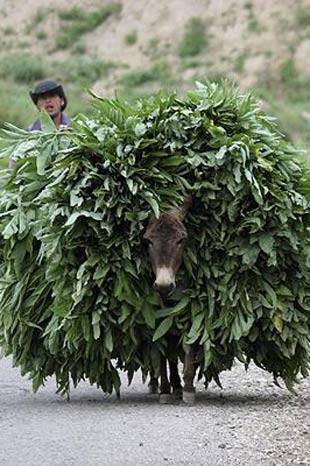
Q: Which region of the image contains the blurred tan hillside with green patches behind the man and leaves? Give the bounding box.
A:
[0,0,310,144]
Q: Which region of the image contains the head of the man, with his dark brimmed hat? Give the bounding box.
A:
[30,80,67,118]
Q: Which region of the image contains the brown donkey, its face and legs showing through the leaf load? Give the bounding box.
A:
[143,196,196,404]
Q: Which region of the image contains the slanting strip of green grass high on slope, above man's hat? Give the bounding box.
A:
[55,3,122,49]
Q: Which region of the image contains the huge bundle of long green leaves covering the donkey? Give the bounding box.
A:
[0,82,310,393]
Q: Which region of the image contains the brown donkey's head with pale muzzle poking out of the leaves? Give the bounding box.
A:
[143,196,192,297]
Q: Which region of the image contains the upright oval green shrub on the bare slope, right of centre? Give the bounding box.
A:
[178,18,207,58]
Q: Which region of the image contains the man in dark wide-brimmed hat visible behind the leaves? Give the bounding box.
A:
[28,80,70,131]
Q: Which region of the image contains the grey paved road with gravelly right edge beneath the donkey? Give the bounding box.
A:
[0,359,310,466]
